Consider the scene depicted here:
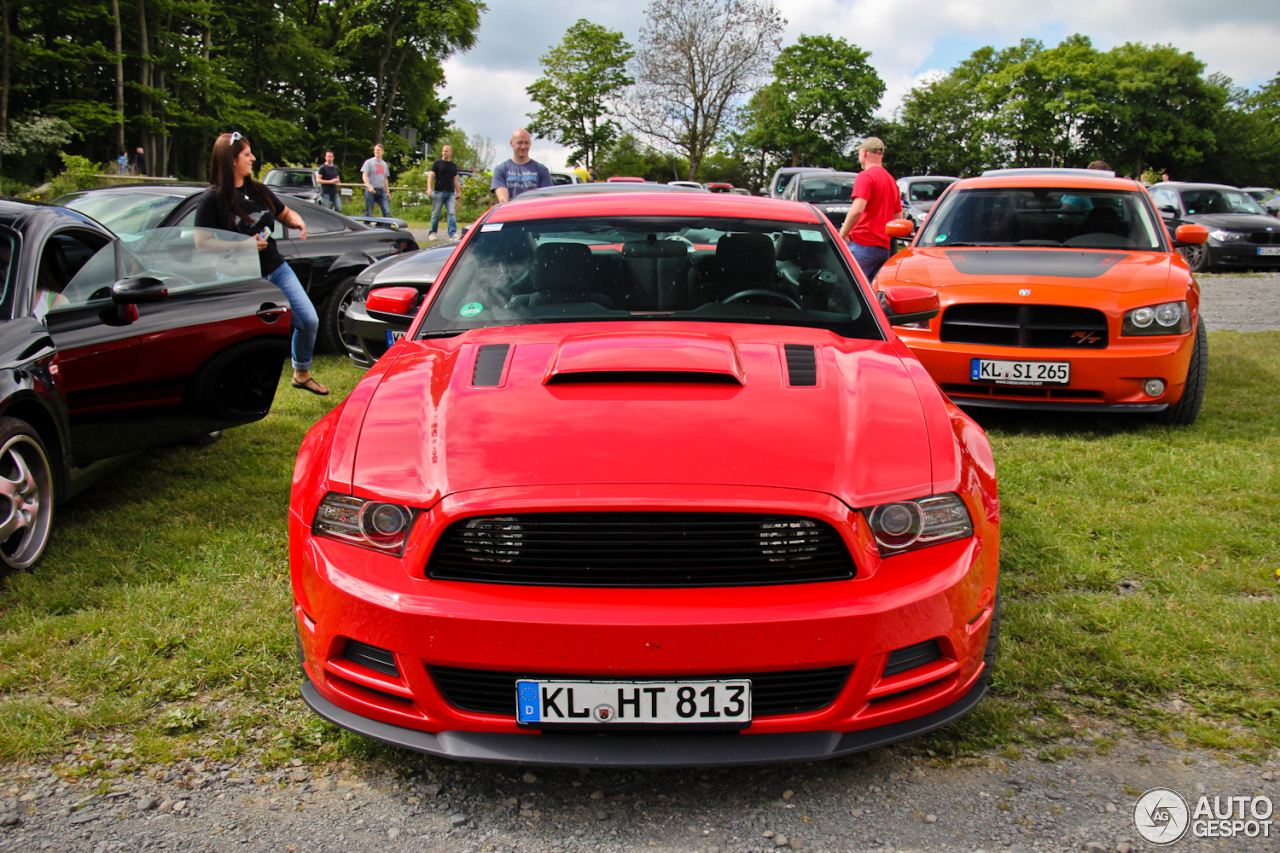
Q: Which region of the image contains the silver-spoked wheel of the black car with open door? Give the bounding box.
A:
[0,418,54,569]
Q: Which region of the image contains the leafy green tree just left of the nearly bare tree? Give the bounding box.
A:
[525,18,635,165]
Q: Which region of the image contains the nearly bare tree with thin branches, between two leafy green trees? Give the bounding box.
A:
[628,0,786,181]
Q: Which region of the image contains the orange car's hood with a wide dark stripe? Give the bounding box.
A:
[879,248,1170,294]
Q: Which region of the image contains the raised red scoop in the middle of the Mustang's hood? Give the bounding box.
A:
[543,332,746,386]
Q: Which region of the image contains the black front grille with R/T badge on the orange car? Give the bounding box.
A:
[942,302,1107,350]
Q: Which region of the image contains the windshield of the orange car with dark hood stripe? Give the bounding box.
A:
[915,187,1164,251]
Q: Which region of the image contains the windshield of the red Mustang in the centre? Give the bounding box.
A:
[419,216,881,338]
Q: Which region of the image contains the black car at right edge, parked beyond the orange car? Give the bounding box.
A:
[1149,182,1280,273]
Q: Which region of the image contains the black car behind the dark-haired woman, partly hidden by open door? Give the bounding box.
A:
[56,183,417,352]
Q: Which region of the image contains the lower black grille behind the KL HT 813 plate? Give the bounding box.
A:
[428,666,852,717]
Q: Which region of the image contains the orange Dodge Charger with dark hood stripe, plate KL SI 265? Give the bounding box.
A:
[876,169,1208,424]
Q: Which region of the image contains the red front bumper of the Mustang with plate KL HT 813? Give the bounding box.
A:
[291,488,998,766]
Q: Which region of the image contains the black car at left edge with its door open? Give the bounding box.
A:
[0,200,289,569]
